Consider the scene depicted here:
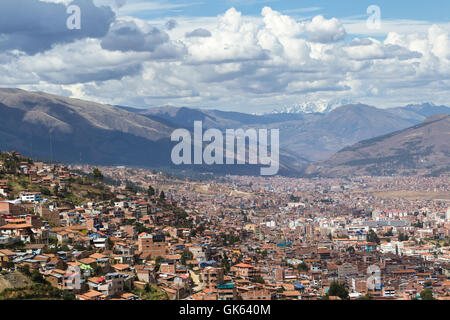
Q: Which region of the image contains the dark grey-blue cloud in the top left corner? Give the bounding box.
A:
[0,0,115,54]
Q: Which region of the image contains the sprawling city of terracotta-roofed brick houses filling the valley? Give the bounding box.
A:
[0,152,450,300]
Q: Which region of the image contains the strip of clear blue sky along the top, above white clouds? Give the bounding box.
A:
[128,0,450,22]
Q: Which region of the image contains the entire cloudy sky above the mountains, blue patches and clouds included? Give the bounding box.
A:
[0,0,450,113]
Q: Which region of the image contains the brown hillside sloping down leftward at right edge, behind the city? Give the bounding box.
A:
[305,114,450,177]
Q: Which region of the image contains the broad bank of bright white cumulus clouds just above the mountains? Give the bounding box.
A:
[0,5,450,112]
